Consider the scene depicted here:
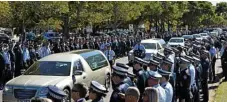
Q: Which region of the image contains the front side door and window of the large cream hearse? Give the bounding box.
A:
[73,60,91,85]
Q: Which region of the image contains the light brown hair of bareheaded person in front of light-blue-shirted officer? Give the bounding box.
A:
[144,87,159,102]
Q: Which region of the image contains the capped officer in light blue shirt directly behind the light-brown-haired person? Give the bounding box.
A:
[147,71,166,102]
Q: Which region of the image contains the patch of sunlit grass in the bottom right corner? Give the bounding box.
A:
[214,82,227,102]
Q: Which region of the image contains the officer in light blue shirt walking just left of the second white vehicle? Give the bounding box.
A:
[133,40,146,58]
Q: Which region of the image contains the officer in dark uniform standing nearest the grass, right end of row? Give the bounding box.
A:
[200,50,210,102]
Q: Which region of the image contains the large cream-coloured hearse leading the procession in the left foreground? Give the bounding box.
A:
[3,49,111,102]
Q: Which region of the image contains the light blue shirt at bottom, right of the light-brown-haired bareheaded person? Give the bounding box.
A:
[161,82,173,102]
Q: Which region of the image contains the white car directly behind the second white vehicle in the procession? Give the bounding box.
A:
[167,37,185,47]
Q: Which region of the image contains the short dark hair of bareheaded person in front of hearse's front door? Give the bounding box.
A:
[72,83,88,98]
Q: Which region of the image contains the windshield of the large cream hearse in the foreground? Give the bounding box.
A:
[24,61,71,76]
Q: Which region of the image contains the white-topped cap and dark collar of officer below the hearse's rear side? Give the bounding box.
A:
[89,81,107,102]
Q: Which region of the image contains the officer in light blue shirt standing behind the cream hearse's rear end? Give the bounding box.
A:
[104,43,115,66]
